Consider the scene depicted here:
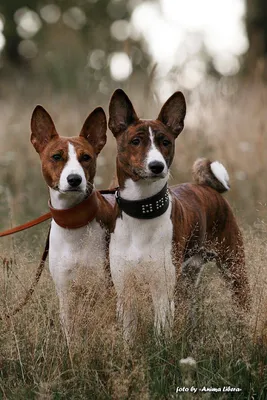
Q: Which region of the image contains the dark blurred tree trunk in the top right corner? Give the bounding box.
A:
[245,0,267,78]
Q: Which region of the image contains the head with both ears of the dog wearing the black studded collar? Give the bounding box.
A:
[109,89,186,181]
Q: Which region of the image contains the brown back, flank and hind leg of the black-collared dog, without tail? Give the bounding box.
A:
[170,183,250,308]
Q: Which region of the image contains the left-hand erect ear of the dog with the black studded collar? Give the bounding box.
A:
[108,89,138,137]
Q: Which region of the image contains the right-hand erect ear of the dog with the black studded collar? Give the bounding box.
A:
[158,92,186,137]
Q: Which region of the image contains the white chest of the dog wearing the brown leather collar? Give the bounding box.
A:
[49,221,106,286]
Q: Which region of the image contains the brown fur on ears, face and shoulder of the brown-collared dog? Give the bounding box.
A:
[31,106,114,231]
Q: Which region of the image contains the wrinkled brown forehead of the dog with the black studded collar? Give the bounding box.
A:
[127,119,173,139]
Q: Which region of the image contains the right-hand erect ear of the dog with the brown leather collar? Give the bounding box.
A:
[80,107,107,154]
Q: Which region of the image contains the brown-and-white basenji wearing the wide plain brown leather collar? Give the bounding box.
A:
[31,106,114,342]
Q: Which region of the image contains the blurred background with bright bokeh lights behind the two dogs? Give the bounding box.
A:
[0,0,267,227]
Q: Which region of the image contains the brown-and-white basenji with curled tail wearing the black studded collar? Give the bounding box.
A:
[109,89,249,340]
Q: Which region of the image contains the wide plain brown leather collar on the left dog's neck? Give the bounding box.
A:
[48,191,98,229]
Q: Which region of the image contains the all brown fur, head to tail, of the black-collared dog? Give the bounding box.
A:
[109,89,250,309]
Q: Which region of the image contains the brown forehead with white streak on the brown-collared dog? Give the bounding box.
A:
[44,136,94,157]
